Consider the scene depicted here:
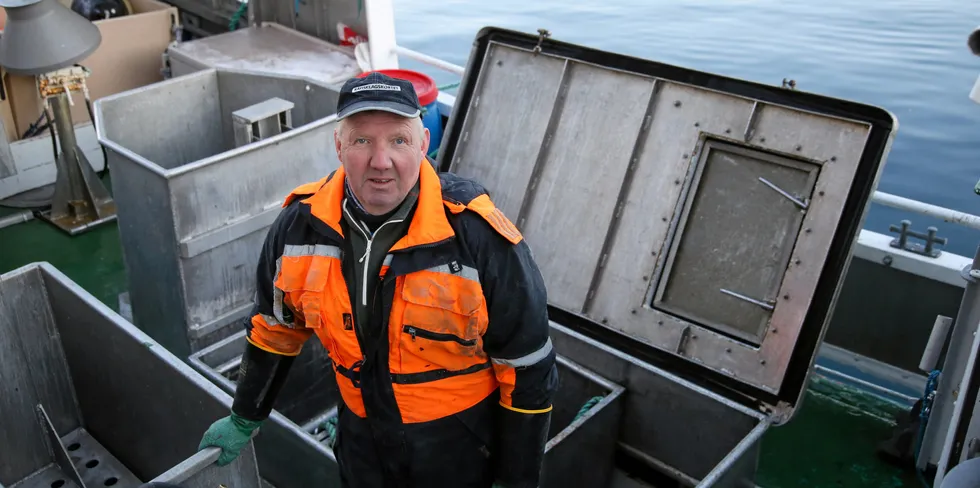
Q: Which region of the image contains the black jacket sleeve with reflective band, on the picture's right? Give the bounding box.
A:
[474,215,559,488]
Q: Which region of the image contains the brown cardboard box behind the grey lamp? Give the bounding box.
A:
[0,0,178,142]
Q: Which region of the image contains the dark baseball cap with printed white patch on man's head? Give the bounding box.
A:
[337,72,422,119]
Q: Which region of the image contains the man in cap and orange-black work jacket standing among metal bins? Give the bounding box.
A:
[201,73,558,488]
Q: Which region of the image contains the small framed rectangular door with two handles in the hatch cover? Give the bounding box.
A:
[652,141,819,345]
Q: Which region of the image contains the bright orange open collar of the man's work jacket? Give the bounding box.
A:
[286,159,456,251]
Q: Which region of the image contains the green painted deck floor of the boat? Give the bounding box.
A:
[0,199,922,488]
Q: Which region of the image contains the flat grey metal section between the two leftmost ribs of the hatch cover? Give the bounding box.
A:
[516,59,653,311]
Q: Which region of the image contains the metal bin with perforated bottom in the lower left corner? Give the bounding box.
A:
[0,263,260,488]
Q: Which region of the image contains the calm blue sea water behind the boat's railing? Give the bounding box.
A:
[394,0,980,257]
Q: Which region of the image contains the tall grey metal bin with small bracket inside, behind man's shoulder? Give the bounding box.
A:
[95,69,340,358]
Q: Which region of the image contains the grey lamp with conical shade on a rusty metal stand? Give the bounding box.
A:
[0,0,116,235]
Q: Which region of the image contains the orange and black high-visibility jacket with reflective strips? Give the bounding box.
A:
[246,161,558,484]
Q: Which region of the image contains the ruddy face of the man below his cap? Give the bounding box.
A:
[334,111,429,215]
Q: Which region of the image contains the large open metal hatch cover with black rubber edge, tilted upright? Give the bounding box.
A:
[439,28,897,411]
